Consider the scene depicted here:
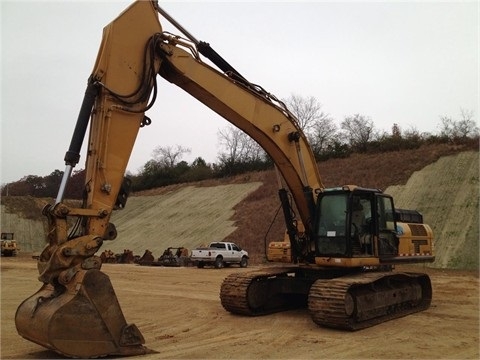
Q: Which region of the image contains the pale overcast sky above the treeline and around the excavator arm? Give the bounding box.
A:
[1,0,479,184]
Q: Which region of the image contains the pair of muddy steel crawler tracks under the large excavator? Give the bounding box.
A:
[220,267,432,330]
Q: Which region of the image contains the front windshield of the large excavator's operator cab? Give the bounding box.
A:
[315,193,348,255]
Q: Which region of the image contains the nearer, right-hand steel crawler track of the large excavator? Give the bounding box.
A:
[308,272,432,330]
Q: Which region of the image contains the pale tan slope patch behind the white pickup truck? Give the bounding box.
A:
[104,182,261,257]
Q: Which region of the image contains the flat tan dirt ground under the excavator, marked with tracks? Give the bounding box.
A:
[0,254,480,359]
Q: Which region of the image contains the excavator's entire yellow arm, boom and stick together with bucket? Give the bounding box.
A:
[15,1,323,357]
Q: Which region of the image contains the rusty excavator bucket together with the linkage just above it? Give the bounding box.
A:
[15,219,147,358]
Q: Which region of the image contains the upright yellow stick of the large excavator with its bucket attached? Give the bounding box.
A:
[15,1,162,358]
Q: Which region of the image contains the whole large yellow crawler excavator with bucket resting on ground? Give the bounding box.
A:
[15,1,434,358]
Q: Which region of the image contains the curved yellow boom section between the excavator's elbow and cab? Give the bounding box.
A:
[159,35,323,236]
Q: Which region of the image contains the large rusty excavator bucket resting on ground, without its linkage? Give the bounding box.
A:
[15,269,147,358]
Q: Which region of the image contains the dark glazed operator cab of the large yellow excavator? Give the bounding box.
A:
[314,185,399,266]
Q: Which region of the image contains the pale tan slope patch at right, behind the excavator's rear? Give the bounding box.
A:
[386,151,479,269]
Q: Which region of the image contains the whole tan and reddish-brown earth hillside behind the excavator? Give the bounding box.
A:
[1,146,479,269]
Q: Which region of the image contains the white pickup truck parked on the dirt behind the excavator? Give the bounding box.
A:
[190,241,248,269]
